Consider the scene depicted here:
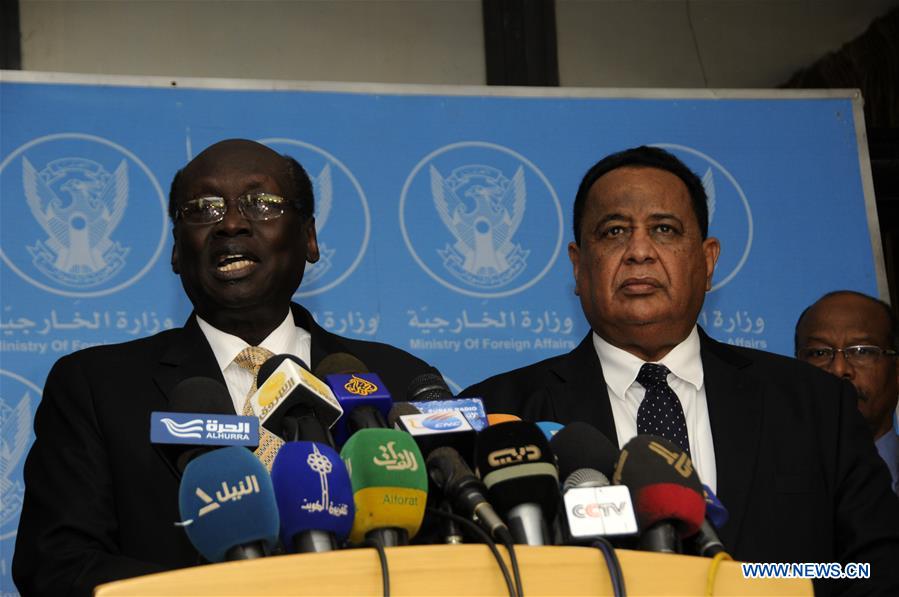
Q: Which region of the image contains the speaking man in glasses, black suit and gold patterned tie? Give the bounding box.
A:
[13,140,435,596]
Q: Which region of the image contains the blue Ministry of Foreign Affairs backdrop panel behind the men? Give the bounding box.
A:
[0,71,886,593]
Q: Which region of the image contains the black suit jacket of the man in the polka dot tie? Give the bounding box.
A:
[463,333,899,595]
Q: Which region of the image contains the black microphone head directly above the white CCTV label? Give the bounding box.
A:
[549,421,618,479]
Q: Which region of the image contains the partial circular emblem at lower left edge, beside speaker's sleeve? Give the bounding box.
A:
[0,369,41,540]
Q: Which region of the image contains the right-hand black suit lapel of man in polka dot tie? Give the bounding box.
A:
[700,332,763,550]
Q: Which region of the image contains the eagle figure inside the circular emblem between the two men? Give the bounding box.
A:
[430,165,529,289]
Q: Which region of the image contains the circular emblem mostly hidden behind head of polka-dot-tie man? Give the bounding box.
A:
[655,143,753,291]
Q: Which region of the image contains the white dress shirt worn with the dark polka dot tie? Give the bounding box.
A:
[593,326,718,492]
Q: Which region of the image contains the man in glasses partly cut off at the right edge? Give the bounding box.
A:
[795,290,899,494]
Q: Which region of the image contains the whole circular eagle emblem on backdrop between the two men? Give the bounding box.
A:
[400,142,562,297]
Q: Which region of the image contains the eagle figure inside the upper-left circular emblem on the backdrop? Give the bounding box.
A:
[22,157,128,288]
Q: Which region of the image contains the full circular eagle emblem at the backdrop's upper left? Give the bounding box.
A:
[0,134,168,297]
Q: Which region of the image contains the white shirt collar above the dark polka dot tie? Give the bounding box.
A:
[593,326,703,400]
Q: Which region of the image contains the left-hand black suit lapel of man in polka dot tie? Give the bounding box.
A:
[549,332,618,446]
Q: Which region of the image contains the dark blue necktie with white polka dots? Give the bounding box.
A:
[637,363,690,454]
